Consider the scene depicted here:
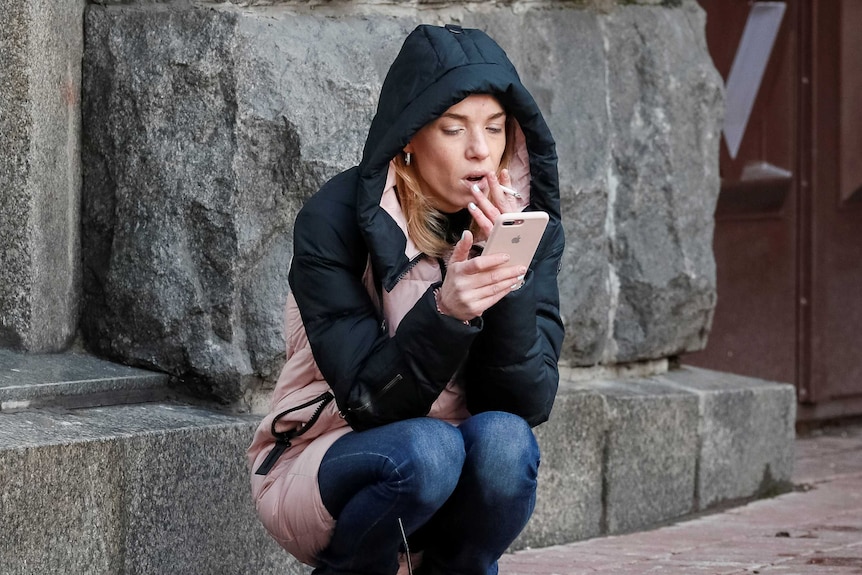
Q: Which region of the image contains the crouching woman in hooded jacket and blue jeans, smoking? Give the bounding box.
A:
[249,26,563,575]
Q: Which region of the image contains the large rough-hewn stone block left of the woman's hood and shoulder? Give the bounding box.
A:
[82,8,392,401]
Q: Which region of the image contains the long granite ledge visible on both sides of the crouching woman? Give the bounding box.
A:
[0,367,796,575]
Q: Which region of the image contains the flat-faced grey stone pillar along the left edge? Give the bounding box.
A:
[0,0,85,351]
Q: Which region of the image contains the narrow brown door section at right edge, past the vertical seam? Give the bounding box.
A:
[799,0,862,418]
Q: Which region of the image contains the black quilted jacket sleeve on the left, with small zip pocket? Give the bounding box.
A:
[289,173,480,429]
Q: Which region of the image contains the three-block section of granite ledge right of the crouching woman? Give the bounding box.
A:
[513,367,796,549]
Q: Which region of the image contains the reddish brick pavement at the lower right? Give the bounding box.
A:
[500,425,862,575]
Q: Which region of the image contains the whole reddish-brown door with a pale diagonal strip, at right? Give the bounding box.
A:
[684,0,862,420]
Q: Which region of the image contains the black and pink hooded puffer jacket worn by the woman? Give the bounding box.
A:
[248,25,564,564]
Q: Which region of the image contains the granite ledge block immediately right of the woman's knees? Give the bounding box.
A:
[512,388,608,549]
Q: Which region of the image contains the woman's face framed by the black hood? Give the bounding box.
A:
[404,94,506,213]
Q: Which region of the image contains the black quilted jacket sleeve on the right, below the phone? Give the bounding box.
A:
[464,220,564,426]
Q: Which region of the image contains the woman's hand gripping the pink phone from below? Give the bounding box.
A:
[437,230,527,321]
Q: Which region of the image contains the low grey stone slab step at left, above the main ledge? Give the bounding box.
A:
[0,349,168,412]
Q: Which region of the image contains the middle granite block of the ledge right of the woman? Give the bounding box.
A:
[584,377,699,534]
